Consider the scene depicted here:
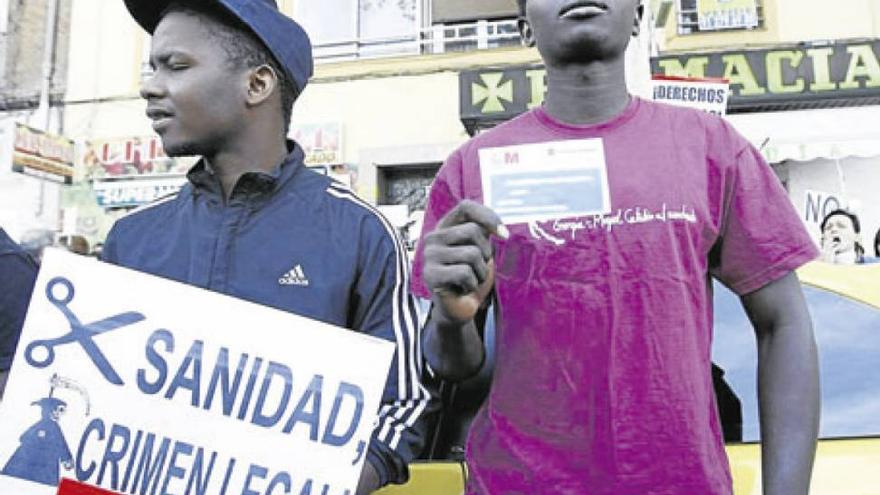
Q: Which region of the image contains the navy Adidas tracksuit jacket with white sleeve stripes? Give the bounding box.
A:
[102,145,430,483]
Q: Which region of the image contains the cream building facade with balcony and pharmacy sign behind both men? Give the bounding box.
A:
[0,0,880,254]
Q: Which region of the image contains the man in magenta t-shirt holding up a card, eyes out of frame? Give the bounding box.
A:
[413,0,819,495]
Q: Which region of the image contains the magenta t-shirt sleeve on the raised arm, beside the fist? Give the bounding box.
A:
[410,151,464,299]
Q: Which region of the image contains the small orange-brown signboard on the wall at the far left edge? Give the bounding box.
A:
[0,122,74,184]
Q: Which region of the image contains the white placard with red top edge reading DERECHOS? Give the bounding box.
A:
[651,76,729,115]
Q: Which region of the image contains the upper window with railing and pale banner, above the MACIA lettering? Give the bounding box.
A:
[678,0,764,34]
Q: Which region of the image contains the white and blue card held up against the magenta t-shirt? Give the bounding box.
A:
[479,138,611,224]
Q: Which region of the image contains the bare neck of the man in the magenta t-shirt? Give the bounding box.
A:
[544,56,630,125]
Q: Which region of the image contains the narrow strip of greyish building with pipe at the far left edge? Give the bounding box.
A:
[0,0,73,238]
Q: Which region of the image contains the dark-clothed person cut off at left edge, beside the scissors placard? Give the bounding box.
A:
[0,228,37,399]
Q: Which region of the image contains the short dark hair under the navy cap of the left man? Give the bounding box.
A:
[160,0,297,135]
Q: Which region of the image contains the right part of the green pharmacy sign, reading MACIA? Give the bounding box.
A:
[651,39,880,112]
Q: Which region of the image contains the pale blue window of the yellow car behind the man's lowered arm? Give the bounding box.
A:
[712,276,880,442]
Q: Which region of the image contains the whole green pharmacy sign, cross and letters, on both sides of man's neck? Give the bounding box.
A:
[459,40,880,130]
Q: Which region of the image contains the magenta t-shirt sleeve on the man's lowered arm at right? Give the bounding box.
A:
[709,145,819,295]
